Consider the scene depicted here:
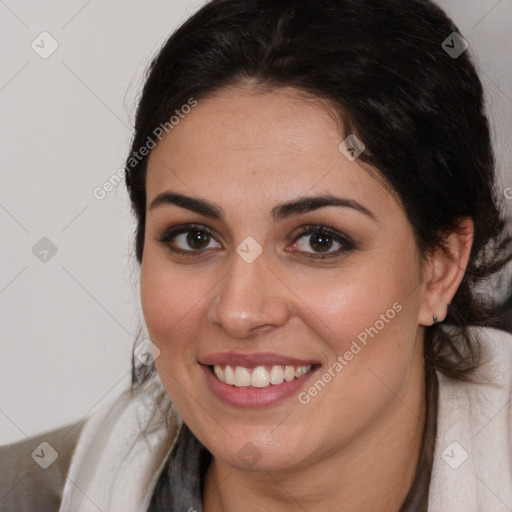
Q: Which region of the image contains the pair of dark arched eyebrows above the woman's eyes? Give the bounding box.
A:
[149,192,377,222]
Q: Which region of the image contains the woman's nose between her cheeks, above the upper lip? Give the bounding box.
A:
[208,254,291,339]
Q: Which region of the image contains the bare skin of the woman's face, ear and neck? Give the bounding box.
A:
[141,84,472,512]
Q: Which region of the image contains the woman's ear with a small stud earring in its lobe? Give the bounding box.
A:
[418,217,474,326]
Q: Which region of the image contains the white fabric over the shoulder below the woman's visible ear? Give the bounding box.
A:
[429,327,512,510]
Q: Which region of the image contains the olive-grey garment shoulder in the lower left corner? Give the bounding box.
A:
[0,419,86,512]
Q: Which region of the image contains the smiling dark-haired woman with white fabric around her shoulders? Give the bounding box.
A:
[1,0,512,512]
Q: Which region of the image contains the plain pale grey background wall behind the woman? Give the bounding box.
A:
[0,0,512,444]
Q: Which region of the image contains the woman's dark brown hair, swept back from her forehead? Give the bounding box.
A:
[126,0,507,385]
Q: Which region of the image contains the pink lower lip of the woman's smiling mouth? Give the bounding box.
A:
[199,364,320,407]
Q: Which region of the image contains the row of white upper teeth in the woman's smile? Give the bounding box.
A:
[213,364,311,388]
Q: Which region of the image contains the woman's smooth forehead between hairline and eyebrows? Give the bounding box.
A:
[146,86,398,216]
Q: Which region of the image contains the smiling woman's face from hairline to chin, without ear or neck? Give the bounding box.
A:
[141,86,424,470]
